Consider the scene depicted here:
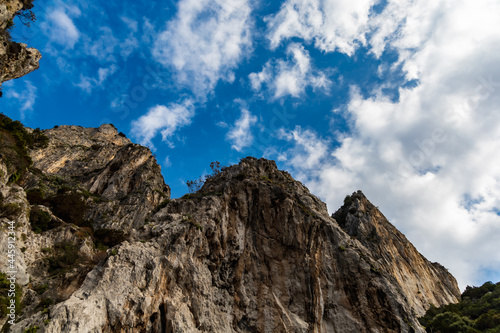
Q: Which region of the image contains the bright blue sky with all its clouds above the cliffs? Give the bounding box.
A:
[1,0,500,288]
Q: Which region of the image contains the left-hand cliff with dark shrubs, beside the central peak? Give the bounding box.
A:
[0,122,170,331]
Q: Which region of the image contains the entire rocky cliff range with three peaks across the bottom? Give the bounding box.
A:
[0,119,460,333]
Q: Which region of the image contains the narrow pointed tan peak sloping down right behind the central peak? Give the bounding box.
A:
[332,191,460,315]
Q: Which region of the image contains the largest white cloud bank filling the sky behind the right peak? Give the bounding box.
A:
[274,0,500,288]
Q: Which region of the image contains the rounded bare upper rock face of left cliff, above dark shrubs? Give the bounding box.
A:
[29,124,170,232]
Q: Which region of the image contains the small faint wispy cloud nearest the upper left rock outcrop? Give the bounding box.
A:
[41,6,81,50]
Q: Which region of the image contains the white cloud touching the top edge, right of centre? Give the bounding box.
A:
[266,0,377,55]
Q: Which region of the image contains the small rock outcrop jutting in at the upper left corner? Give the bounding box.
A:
[0,0,42,96]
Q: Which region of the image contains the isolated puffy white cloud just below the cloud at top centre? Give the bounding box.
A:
[248,43,331,99]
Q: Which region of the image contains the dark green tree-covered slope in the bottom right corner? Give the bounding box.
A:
[419,282,500,333]
